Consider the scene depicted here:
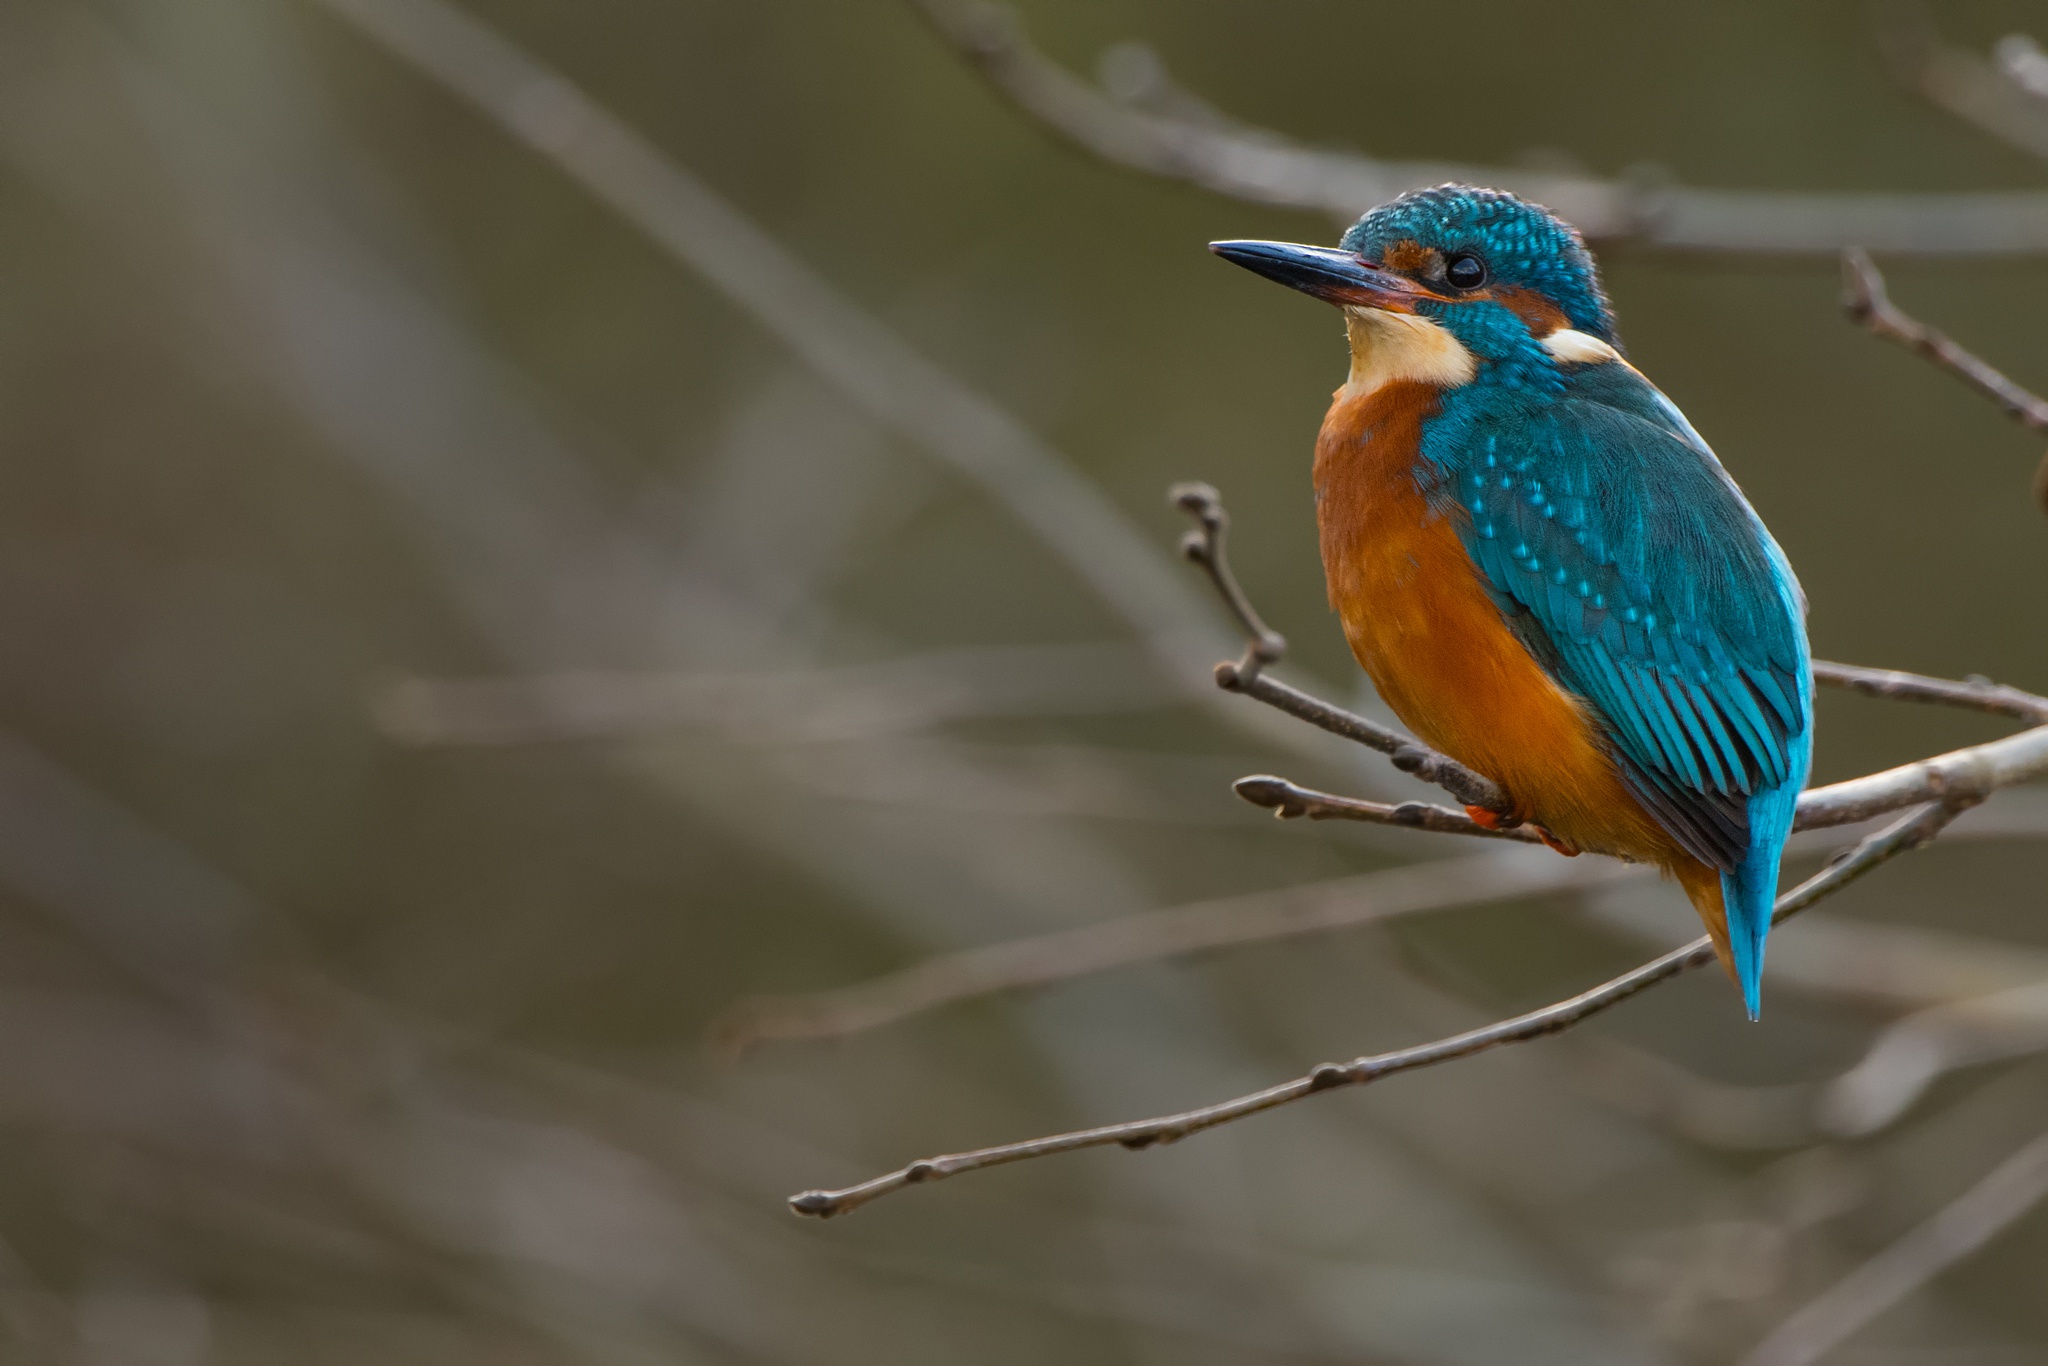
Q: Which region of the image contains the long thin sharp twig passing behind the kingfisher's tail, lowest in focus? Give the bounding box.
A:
[788,797,1974,1216]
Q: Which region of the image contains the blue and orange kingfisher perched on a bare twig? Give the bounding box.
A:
[1210,184,1812,1018]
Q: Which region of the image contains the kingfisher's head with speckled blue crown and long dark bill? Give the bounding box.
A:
[1210,184,1616,377]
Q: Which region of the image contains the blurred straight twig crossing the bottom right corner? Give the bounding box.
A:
[1741,1135,2048,1366]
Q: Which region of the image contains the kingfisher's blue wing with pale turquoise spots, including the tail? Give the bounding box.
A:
[1438,362,1812,1011]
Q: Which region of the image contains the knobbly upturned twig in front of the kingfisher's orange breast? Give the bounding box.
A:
[1171,483,1513,817]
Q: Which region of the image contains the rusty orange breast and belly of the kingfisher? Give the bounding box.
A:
[1315,381,1687,876]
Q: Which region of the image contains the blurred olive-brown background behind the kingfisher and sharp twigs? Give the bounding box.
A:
[0,0,2048,1366]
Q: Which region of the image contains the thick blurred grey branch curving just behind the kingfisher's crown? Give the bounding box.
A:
[913,0,2048,254]
